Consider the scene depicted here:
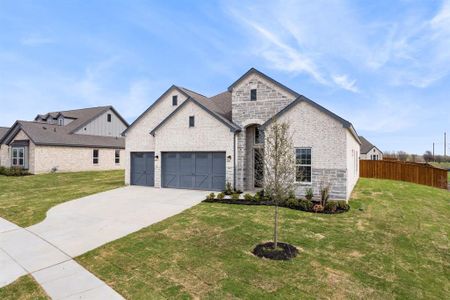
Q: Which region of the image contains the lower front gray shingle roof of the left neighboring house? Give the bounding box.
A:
[3,121,125,149]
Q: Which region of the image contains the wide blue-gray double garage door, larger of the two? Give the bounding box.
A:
[161,152,225,191]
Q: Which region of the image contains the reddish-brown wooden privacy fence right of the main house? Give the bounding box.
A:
[359,160,447,189]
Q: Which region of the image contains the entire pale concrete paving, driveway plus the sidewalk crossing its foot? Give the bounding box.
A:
[0,186,207,299]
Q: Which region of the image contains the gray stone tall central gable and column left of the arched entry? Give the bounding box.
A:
[232,74,295,190]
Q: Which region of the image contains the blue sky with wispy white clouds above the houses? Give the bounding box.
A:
[0,0,450,153]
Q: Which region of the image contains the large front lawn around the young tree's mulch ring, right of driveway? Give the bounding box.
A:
[77,179,450,299]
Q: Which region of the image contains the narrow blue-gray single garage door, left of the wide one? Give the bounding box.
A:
[130,152,155,186]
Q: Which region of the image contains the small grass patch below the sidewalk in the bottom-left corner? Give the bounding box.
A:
[0,275,50,300]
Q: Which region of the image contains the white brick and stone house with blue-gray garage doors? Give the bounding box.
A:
[124,68,360,199]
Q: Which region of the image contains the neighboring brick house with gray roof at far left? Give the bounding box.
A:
[0,106,128,174]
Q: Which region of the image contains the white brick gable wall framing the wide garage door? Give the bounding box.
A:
[155,102,234,188]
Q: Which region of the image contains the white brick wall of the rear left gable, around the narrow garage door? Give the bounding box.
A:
[125,88,187,184]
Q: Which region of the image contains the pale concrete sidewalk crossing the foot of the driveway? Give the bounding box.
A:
[0,218,123,299]
